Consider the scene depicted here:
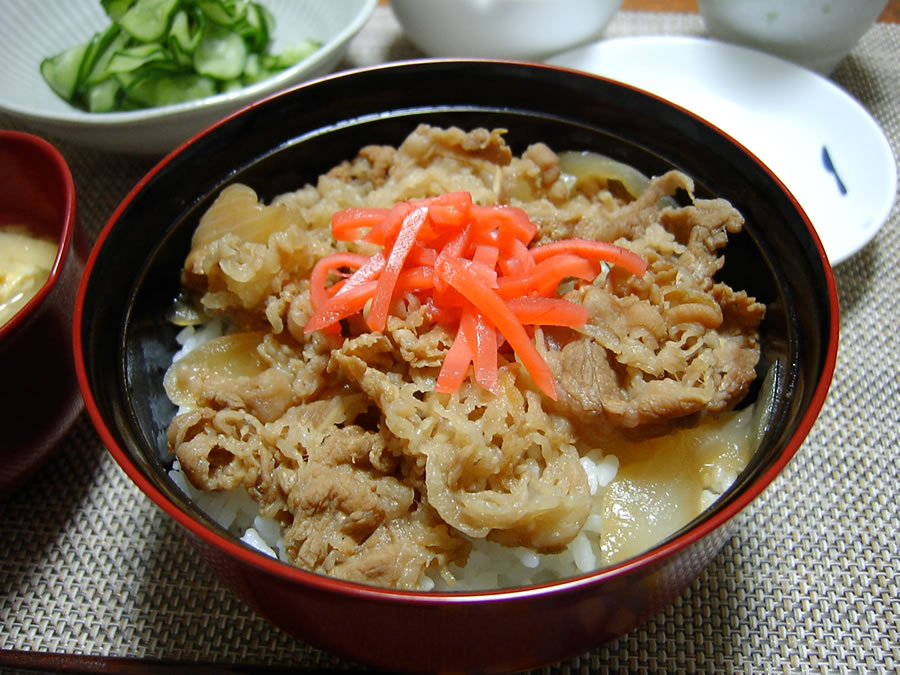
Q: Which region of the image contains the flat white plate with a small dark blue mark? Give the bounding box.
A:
[547,36,897,265]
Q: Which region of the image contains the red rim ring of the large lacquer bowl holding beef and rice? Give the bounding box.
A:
[73,59,839,605]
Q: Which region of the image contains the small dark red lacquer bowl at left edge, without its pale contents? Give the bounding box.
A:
[0,131,85,496]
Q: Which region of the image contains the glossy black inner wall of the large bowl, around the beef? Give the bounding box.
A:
[76,61,832,564]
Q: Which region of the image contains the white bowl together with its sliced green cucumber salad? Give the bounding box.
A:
[0,0,378,157]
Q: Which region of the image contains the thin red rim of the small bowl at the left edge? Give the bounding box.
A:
[0,130,77,341]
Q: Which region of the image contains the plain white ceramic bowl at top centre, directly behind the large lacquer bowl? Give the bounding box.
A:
[391,0,622,60]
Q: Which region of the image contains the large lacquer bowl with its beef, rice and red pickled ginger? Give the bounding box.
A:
[74,61,838,670]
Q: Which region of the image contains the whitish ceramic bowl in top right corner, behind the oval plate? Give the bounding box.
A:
[698,0,887,75]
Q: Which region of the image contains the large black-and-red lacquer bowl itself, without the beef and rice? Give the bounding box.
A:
[74,61,838,670]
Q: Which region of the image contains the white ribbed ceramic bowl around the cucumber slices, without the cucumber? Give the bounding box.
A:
[0,0,378,154]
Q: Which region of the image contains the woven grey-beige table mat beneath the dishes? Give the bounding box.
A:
[0,7,900,673]
